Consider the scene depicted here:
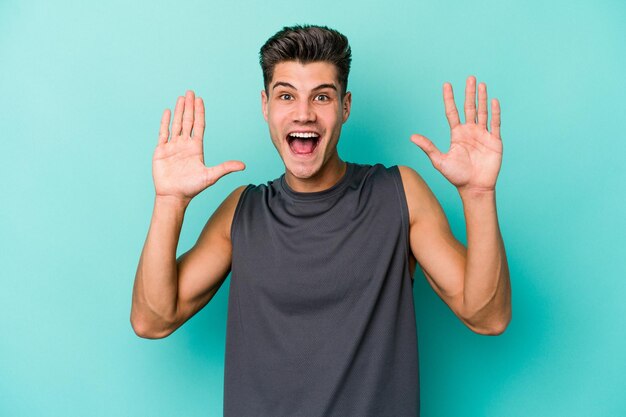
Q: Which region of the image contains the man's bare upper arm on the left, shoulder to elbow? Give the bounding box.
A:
[176,186,245,326]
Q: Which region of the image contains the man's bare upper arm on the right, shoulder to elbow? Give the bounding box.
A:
[399,166,469,325]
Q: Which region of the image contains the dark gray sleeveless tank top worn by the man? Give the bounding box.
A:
[224,163,419,417]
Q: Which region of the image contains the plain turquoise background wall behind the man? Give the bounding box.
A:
[0,0,626,417]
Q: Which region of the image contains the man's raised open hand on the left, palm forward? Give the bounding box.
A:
[152,91,245,203]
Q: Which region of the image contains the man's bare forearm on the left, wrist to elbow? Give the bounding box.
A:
[131,197,187,335]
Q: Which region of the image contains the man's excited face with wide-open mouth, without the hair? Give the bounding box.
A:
[261,61,352,180]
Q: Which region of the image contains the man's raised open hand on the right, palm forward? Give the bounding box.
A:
[411,76,502,191]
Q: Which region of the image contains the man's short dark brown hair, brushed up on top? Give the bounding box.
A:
[259,25,352,96]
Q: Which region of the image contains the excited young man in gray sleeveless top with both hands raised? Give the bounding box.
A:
[131,26,511,416]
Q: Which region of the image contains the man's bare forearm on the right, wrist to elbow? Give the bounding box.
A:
[461,191,511,331]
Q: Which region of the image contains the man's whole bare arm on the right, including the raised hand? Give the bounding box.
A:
[401,76,512,335]
